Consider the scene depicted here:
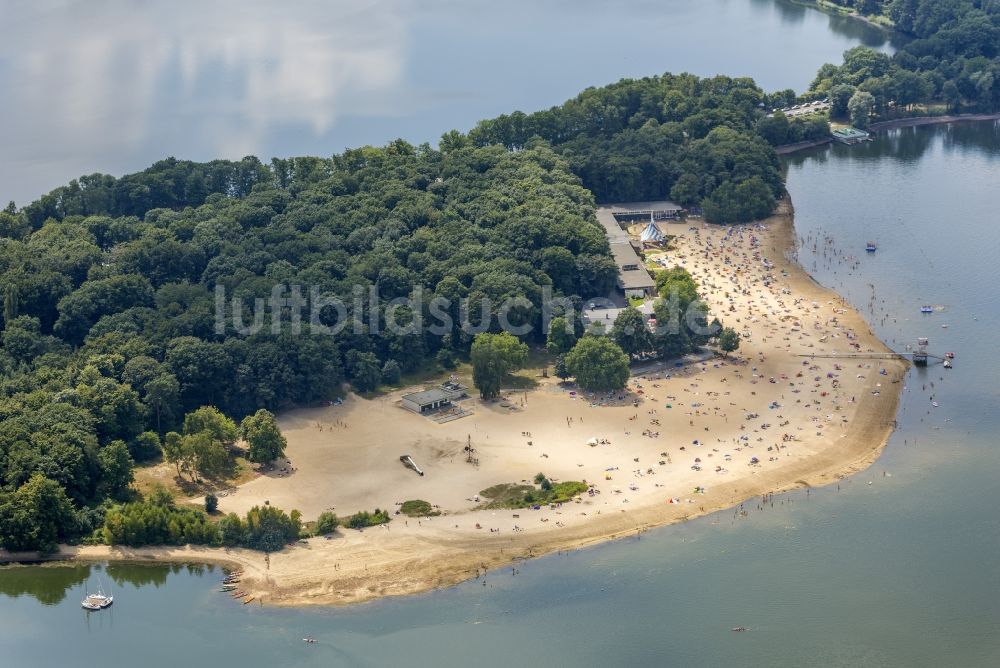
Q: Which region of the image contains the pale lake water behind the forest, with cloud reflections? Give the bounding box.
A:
[0,0,891,205]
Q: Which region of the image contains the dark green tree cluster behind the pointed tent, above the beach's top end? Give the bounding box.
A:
[468,74,794,222]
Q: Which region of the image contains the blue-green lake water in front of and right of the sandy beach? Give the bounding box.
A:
[0,2,1000,668]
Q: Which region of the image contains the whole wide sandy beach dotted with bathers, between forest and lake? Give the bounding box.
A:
[7,201,906,605]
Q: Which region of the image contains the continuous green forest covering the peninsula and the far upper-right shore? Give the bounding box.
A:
[0,0,1000,549]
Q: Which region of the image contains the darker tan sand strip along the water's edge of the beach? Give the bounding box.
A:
[0,197,912,606]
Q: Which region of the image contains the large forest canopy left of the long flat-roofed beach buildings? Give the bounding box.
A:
[0,141,615,547]
